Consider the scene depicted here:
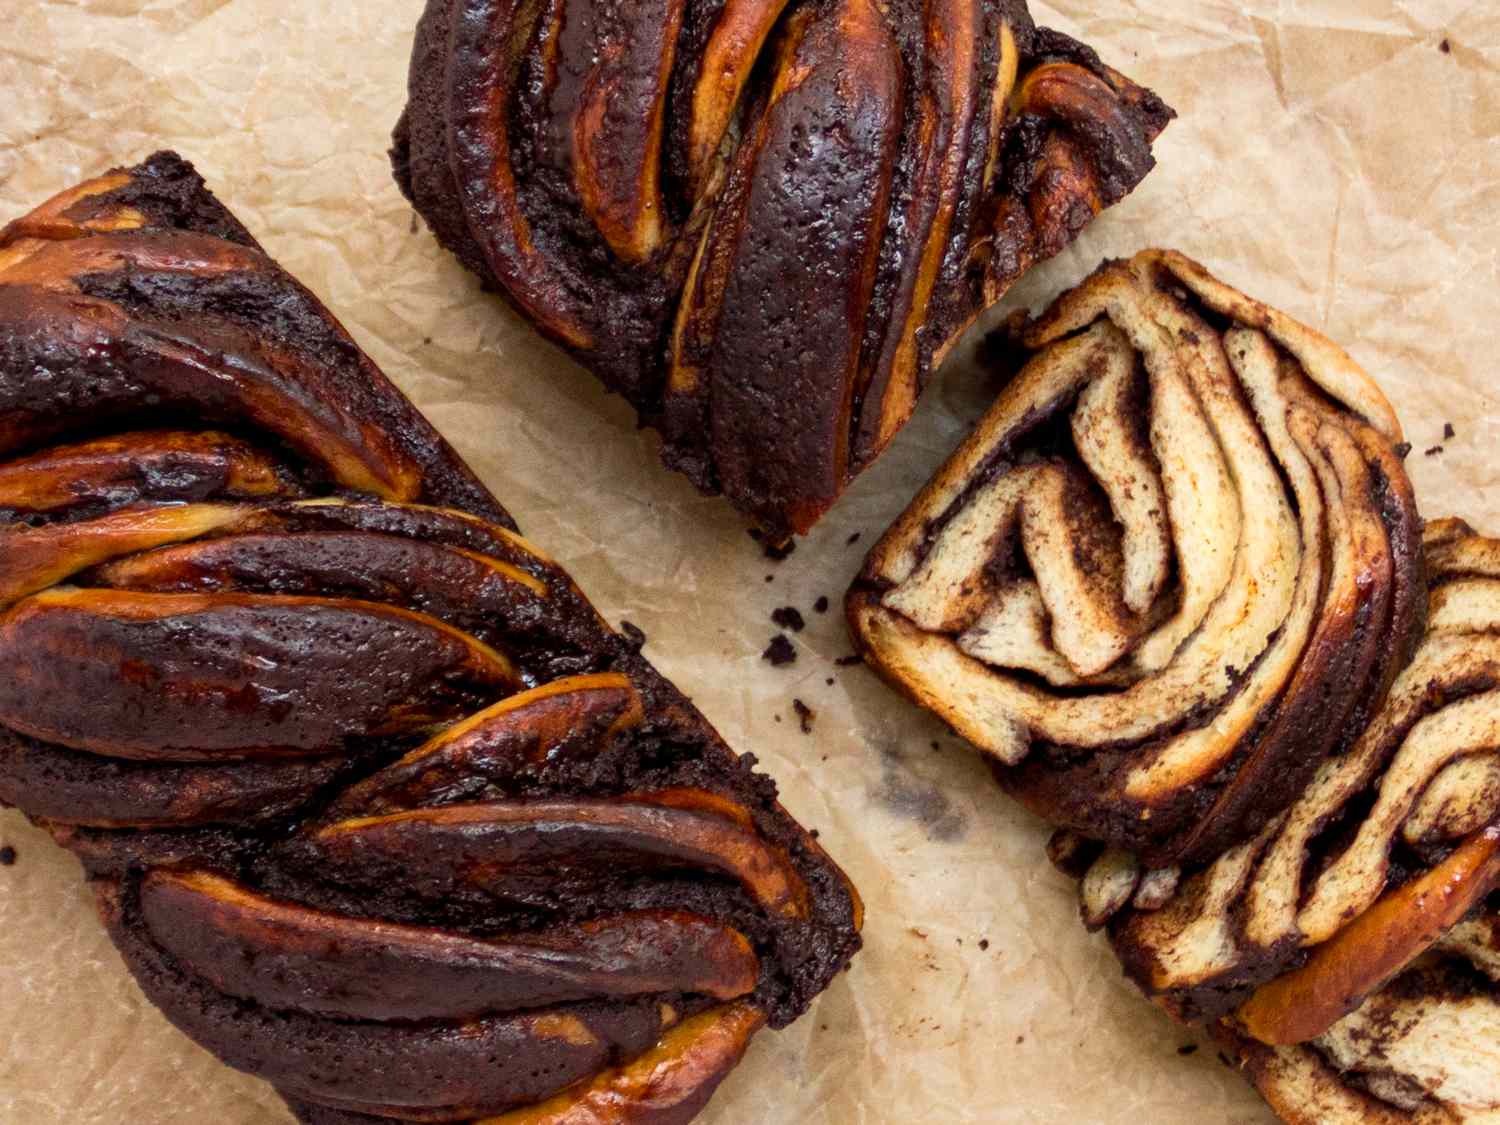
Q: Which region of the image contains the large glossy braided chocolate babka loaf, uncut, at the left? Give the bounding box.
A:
[0,155,860,1125]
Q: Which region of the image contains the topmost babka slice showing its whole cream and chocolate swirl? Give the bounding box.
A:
[848,252,1421,867]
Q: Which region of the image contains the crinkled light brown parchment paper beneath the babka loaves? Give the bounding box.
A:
[0,0,1500,1125]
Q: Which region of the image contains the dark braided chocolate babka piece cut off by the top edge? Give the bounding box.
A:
[393,0,1172,537]
